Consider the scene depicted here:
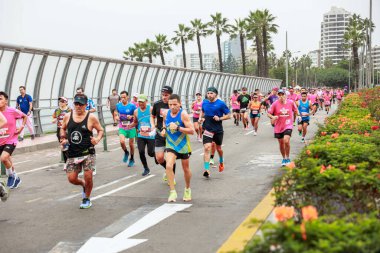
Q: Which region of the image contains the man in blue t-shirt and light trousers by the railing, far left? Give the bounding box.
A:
[16,86,34,141]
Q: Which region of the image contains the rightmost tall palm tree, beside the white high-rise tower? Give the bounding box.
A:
[344,14,365,90]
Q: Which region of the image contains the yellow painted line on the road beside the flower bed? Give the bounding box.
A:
[217,189,275,253]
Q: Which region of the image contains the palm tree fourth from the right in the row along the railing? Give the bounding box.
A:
[208,12,231,72]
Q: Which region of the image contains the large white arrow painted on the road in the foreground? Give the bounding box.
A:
[77,204,191,253]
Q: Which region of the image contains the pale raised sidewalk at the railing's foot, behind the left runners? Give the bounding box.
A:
[13,125,119,155]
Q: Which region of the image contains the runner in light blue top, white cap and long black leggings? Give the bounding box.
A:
[133,94,156,176]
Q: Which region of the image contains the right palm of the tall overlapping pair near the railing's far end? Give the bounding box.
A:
[256,9,278,77]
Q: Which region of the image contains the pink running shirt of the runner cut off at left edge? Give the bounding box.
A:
[0,106,23,146]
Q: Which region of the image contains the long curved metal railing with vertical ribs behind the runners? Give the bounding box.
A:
[0,43,281,135]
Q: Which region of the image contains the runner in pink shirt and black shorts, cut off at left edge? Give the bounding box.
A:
[0,91,27,201]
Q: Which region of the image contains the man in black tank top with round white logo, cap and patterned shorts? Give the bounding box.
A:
[61,94,104,209]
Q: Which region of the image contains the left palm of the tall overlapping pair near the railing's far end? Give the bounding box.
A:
[246,11,264,76]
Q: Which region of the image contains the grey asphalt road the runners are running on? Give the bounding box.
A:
[0,105,332,253]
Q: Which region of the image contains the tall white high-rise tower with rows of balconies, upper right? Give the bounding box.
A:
[321,6,351,65]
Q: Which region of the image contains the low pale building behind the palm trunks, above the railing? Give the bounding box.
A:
[173,53,218,71]
